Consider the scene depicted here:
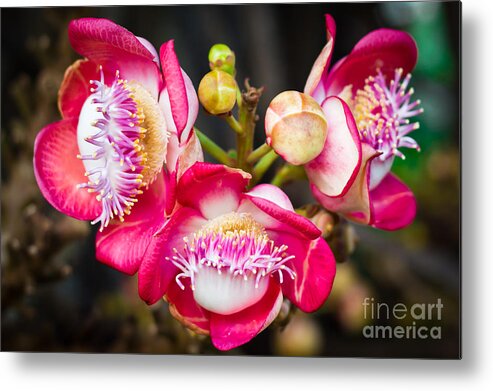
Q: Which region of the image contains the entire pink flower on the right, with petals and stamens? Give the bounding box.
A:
[304,15,422,230]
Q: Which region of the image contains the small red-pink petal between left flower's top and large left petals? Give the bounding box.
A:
[58,59,108,118]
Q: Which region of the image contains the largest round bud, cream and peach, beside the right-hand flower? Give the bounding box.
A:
[265,91,327,166]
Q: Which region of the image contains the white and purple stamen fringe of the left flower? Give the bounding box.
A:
[78,71,146,230]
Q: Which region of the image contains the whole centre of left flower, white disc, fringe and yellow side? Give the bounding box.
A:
[77,71,168,230]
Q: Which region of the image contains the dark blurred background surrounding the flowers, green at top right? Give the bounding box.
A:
[1,2,461,358]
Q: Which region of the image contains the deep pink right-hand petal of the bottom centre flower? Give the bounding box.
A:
[268,231,336,312]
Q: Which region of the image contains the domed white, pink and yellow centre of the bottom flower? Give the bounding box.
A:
[167,212,295,315]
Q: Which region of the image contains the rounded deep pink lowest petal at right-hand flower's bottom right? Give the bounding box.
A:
[370,174,416,231]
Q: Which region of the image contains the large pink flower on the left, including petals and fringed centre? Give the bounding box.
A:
[34,18,201,274]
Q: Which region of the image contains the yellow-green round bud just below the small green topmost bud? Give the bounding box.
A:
[199,69,236,115]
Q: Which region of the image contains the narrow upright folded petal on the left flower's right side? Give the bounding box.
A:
[159,40,199,143]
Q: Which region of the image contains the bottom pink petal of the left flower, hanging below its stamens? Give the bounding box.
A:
[96,173,166,274]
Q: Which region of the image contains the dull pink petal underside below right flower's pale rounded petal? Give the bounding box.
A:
[311,143,379,224]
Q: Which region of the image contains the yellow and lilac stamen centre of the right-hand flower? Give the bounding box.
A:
[350,68,423,188]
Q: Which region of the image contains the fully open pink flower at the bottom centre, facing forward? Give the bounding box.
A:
[139,163,335,350]
